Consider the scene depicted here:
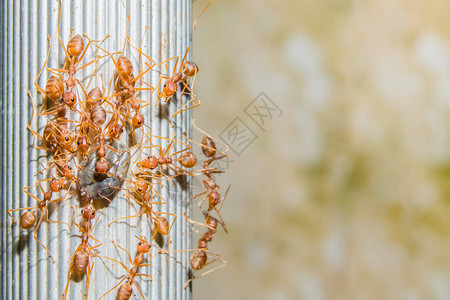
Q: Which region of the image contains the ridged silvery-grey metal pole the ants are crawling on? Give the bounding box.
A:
[0,0,192,299]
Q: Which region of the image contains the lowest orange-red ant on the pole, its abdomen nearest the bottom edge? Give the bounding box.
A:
[97,236,152,300]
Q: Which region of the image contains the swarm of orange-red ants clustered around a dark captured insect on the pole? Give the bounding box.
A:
[8,2,229,299]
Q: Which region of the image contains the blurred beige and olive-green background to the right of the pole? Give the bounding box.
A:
[193,0,450,300]
